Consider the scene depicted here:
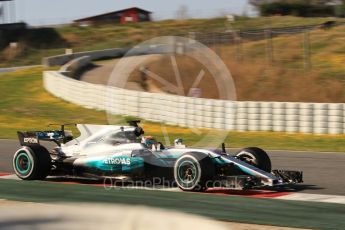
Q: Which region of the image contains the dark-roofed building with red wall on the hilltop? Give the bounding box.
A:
[74,7,152,26]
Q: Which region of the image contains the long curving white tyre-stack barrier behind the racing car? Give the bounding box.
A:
[43,71,345,134]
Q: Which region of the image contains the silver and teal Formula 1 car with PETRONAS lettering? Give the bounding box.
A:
[13,121,303,191]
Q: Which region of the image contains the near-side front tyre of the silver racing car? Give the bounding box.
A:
[174,152,215,192]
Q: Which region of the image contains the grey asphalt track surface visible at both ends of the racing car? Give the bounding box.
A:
[0,140,345,195]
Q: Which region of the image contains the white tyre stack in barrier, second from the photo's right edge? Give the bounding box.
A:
[313,103,328,134]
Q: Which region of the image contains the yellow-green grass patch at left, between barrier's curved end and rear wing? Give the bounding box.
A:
[0,68,106,133]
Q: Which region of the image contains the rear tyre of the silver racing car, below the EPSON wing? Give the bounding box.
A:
[13,145,51,180]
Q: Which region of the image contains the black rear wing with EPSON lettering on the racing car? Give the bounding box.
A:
[17,124,73,146]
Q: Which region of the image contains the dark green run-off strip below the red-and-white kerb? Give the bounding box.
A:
[0,179,345,229]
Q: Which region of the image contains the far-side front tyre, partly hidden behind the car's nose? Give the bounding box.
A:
[236,147,272,172]
